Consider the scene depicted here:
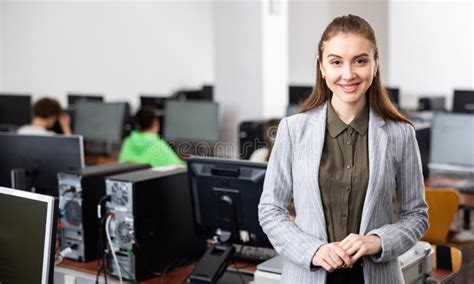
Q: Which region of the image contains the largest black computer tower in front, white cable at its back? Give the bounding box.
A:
[106,168,206,281]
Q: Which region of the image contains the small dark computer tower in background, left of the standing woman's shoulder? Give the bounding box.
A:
[239,120,266,160]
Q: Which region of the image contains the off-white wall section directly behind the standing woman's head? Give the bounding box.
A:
[288,0,388,85]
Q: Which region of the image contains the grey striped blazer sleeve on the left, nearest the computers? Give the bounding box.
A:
[258,118,326,270]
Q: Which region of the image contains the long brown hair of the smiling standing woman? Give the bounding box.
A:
[300,15,412,124]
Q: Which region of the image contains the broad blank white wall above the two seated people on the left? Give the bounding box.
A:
[0,0,214,108]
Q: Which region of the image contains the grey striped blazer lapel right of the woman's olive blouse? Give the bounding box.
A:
[360,110,388,234]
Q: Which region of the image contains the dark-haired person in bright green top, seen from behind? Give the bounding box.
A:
[119,107,184,167]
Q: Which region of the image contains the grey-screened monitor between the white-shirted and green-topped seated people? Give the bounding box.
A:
[74,101,127,144]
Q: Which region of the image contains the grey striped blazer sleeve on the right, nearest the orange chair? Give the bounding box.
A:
[368,124,429,262]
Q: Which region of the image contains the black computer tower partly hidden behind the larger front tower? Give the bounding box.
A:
[58,163,150,262]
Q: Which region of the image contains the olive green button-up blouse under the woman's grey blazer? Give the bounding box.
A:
[319,102,369,242]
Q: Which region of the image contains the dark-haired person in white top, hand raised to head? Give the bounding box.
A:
[17,98,72,135]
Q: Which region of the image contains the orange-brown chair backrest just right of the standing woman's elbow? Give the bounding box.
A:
[422,187,459,244]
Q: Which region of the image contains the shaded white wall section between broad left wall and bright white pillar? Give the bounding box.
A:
[214,1,263,153]
